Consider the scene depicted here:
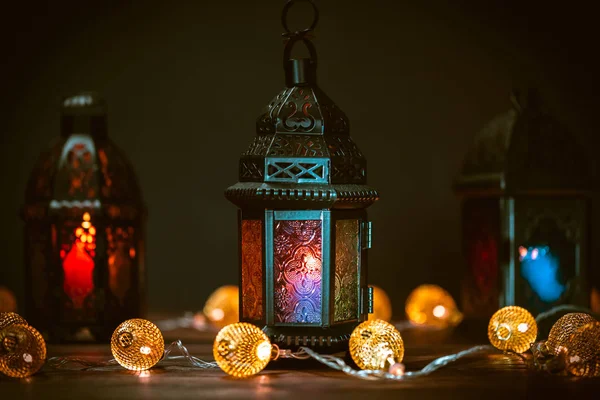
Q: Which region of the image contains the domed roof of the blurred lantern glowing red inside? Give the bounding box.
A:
[23,92,144,219]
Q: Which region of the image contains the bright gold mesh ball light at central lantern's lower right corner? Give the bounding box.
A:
[349,319,404,370]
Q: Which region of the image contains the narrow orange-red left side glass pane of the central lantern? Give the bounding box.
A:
[242,220,263,320]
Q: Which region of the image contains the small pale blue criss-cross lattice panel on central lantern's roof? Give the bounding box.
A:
[265,157,329,183]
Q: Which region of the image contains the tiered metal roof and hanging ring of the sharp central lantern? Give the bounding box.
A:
[225,8,379,208]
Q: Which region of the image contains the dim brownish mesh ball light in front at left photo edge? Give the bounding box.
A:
[0,324,46,378]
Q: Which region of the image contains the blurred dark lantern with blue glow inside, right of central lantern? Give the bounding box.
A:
[456,90,592,318]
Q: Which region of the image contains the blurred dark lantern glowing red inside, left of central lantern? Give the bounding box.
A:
[22,93,145,341]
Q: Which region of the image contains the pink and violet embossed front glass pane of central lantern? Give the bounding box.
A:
[273,220,323,324]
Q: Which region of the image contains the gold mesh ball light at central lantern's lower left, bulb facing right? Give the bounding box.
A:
[213,322,272,378]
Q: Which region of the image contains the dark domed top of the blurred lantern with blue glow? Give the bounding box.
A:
[455,89,592,194]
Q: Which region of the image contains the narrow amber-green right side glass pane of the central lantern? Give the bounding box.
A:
[334,219,360,322]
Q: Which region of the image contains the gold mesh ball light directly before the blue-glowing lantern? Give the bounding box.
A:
[488,306,537,353]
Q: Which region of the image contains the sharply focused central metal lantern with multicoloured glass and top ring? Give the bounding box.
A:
[226,1,378,351]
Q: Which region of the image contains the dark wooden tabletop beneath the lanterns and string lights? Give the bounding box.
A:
[0,324,600,400]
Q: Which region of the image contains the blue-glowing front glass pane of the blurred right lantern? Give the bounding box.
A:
[518,219,576,312]
